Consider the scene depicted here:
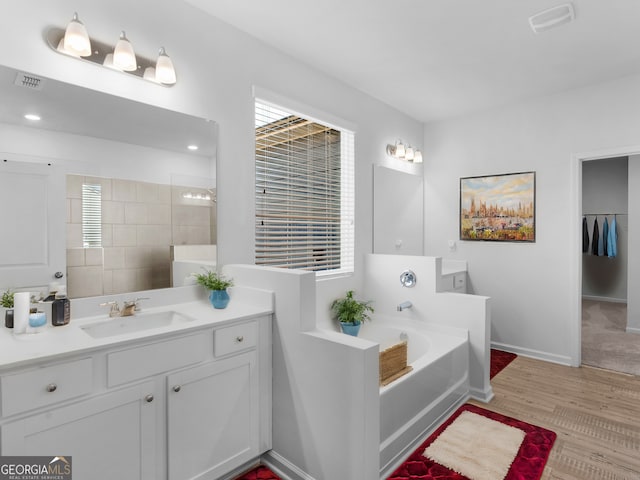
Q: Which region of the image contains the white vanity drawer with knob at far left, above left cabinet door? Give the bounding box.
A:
[0,358,93,417]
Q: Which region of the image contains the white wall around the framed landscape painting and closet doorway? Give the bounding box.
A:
[424,72,640,364]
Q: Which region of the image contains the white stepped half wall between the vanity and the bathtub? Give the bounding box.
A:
[224,265,380,480]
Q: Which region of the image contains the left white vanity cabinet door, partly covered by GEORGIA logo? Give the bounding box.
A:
[0,382,162,480]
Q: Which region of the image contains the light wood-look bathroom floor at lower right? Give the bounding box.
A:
[471,357,640,480]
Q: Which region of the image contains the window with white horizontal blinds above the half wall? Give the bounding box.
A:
[255,101,354,275]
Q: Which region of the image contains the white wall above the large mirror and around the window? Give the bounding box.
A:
[0,0,423,318]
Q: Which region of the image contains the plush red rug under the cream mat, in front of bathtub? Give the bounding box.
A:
[387,404,556,480]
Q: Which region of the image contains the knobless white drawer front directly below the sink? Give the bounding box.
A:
[107,333,211,387]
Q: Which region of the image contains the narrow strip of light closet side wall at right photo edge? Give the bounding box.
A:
[627,155,640,333]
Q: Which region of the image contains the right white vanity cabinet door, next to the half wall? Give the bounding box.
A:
[167,351,259,480]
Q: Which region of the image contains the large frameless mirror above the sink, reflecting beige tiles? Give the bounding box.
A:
[0,62,217,298]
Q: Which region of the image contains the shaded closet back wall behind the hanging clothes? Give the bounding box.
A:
[582,157,629,302]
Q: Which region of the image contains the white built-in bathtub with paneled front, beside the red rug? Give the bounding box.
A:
[359,317,469,478]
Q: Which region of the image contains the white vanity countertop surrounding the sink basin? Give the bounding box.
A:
[0,289,273,372]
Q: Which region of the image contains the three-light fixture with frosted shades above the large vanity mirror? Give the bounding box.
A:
[46,13,176,86]
